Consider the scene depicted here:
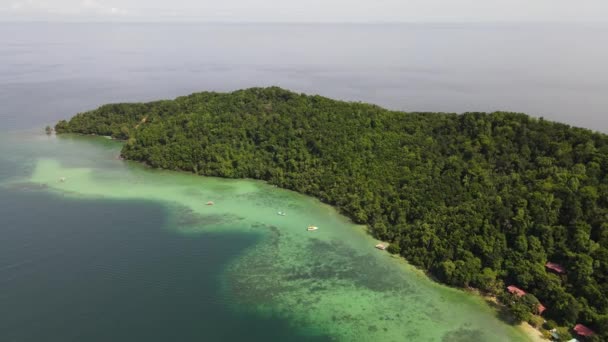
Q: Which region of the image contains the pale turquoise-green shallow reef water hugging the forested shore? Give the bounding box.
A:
[20,148,530,342]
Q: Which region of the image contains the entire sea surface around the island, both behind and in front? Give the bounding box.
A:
[0,23,608,342]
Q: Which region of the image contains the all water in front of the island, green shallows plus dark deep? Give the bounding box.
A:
[0,133,526,341]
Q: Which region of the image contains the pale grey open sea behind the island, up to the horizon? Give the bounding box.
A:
[0,23,608,131]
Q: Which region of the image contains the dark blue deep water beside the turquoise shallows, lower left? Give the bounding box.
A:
[0,188,329,342]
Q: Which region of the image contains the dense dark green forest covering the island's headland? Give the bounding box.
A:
[55,87,608,340]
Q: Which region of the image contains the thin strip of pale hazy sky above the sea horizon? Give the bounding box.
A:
[0,0,608,22]
